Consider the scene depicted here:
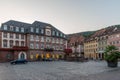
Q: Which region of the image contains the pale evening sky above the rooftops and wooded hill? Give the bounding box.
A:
[0,0,120,34]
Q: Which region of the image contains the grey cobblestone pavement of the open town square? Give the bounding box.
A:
[0,61,120,80]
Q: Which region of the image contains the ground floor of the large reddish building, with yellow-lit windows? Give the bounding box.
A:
[0,49,64,62]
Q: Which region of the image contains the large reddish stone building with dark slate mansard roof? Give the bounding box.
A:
[0,20,66,62]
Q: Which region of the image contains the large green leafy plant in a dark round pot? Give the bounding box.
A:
[104,45,120,67]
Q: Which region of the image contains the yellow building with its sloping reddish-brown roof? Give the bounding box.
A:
[84,29,106,59]
